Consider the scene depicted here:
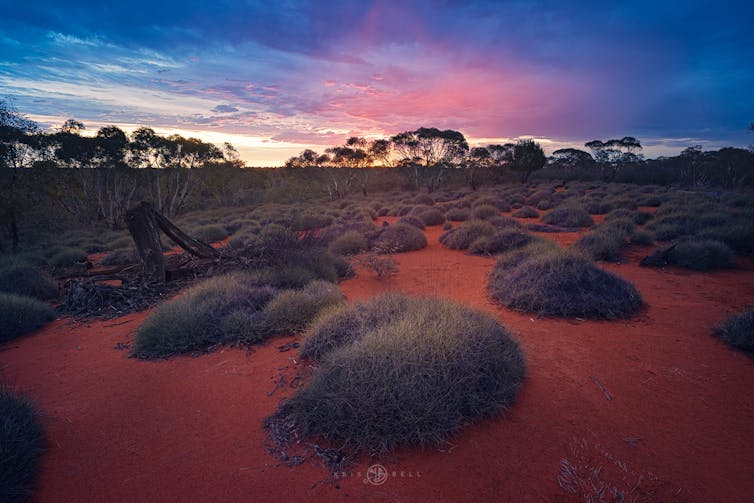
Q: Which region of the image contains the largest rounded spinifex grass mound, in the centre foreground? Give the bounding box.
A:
[280,294,525,454]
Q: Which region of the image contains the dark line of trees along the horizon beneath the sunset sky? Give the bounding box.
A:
[0,99,754,248]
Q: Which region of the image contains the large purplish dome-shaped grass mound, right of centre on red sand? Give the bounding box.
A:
[488,247,643,319]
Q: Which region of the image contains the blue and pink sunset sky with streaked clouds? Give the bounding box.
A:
[0,0,754,166]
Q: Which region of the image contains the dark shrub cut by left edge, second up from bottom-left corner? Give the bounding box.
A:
[0,293,55,343]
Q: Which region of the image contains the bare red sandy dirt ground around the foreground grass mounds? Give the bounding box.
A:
[0,222,754,502]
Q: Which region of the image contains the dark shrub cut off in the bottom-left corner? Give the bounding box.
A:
[0,387,47,503]
